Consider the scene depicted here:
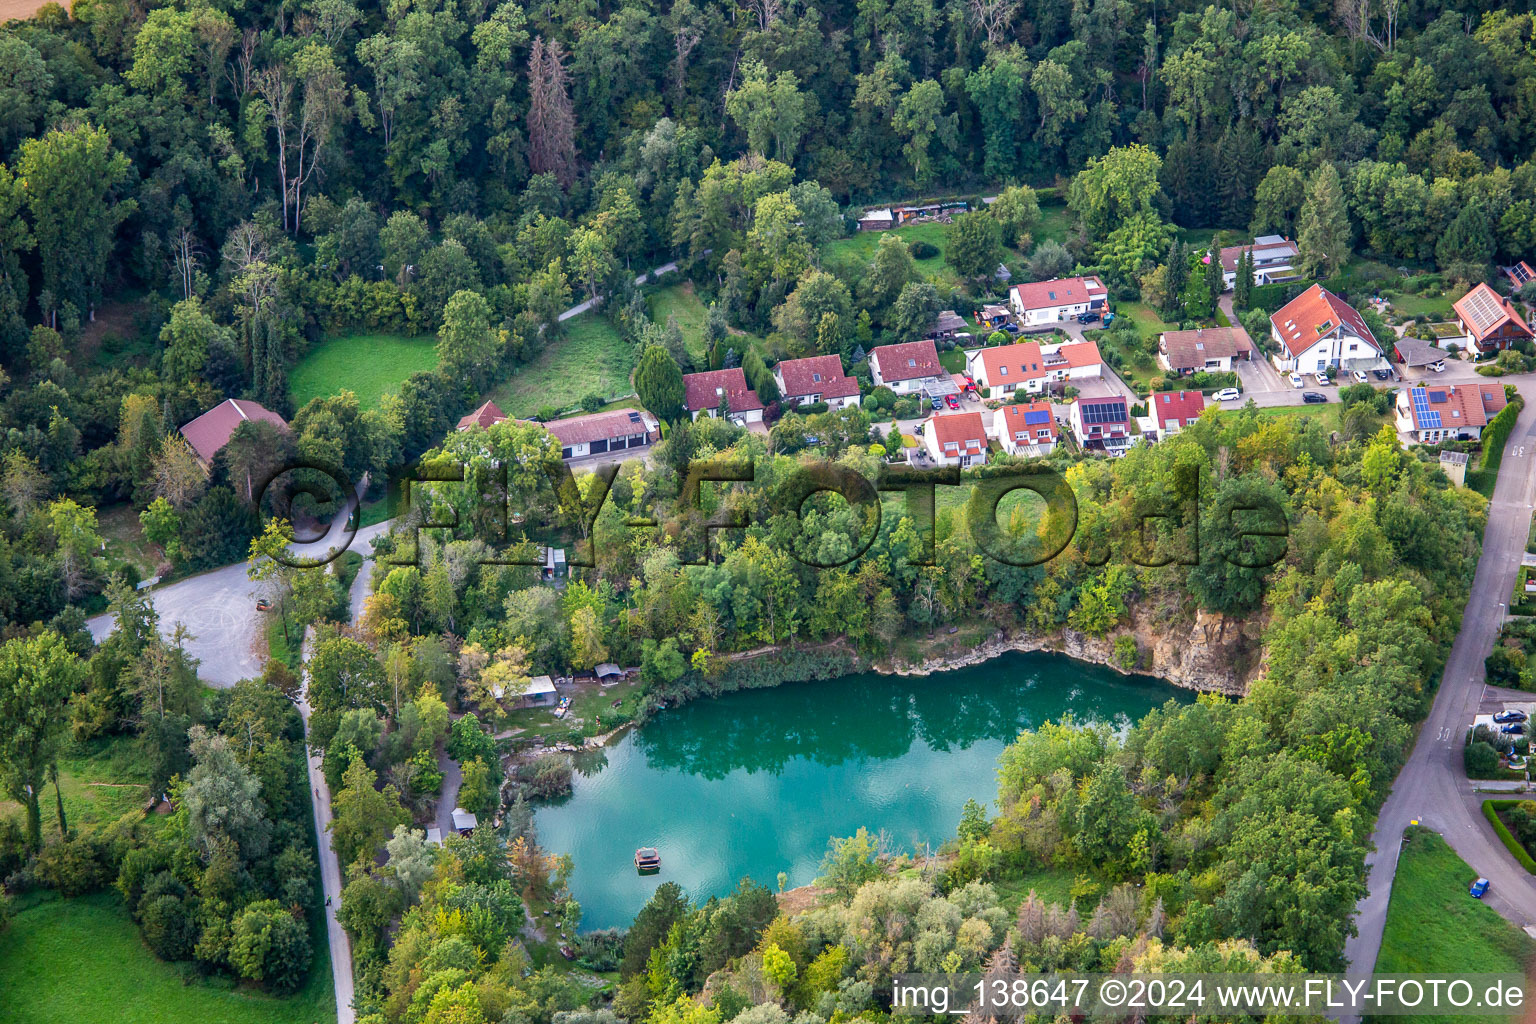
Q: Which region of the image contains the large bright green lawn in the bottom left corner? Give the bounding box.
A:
[0,892,336,1024]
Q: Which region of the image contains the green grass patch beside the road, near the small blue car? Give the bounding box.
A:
[1376,826,1536,1022]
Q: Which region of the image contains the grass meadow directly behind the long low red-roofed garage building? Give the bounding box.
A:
[492,313,634,418]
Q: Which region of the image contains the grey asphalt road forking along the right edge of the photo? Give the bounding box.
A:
[1344,388,1536,972]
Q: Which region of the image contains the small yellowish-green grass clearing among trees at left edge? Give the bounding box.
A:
[0,735,158,847]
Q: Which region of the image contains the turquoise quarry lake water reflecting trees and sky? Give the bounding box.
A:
[535,652,1193,930]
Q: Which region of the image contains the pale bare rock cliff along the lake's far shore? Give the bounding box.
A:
[872,609,1261,697]
